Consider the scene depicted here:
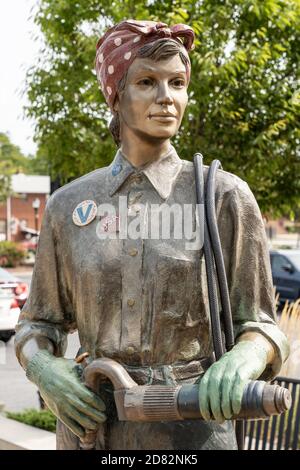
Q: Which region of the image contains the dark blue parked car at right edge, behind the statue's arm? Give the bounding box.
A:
[270,250,300,303]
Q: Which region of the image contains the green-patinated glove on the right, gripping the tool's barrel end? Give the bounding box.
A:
[199,341,268,423]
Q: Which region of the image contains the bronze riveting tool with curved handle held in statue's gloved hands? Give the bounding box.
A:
[76,358,291,436]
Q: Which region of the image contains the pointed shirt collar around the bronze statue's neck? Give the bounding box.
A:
[108,145,182,199]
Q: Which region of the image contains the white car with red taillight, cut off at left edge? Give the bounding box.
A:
[0,288,20,343]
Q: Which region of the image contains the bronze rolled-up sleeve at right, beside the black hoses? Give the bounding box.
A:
[218,178,289,380]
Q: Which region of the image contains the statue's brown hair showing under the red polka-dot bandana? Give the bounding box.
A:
[109,39,190,146]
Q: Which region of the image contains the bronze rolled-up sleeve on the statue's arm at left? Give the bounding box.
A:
[15,198,76,359]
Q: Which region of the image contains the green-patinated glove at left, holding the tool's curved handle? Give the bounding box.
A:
[26,350,106,437]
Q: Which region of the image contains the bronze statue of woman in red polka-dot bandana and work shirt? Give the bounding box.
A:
[15,20,288,449]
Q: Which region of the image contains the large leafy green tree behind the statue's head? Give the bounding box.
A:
[27,0,300,215]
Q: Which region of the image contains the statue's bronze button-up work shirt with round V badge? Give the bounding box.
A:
[16,147,288,448]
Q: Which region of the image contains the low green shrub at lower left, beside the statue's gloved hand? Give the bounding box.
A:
[6,408,56,432]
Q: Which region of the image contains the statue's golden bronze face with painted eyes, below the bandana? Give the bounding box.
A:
[115,54,188,140]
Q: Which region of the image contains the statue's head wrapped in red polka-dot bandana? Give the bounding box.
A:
[96,20,194,144]
